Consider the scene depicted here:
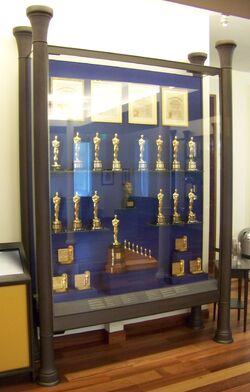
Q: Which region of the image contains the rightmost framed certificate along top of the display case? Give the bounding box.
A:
[162,87,188,127]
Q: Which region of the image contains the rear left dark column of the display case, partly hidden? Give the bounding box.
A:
[13,26,34,264]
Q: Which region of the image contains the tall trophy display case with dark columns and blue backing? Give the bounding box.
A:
[13,6,235,385]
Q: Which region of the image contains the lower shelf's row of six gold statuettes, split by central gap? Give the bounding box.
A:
[52,188,197,232]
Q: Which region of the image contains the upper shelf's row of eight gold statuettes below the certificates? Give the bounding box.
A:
[51,132,197,171]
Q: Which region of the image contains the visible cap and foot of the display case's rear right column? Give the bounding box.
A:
[188,52,207,329]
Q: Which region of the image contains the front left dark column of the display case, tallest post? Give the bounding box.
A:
[27,6,59,386]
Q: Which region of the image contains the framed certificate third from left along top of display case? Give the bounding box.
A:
[128,83,159,125]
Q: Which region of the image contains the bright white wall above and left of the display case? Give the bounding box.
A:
[0,0,209,242]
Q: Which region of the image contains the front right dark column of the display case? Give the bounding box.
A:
[214,41,236,343]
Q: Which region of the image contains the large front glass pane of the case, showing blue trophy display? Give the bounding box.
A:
[49,53,218,311]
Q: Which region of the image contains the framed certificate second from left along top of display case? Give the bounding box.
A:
[91,80,122,123]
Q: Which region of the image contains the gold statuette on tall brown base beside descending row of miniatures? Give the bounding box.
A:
[106,215,126,274]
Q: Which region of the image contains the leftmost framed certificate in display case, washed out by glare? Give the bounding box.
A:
[49,77,84,121]
